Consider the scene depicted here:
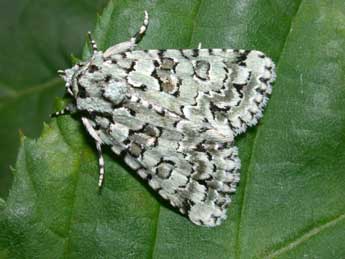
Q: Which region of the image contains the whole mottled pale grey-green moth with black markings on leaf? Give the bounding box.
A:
[54,11,275,227]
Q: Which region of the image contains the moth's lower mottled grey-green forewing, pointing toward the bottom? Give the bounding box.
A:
[86,97,240,226]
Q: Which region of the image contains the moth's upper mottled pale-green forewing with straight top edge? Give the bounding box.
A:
[112,49,275,135]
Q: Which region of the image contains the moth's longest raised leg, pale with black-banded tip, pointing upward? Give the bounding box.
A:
[103,11,149,58]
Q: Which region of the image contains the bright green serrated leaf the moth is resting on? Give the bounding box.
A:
[0,0,345,258]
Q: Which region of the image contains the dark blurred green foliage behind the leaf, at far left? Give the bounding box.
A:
[0,0,108,197]
